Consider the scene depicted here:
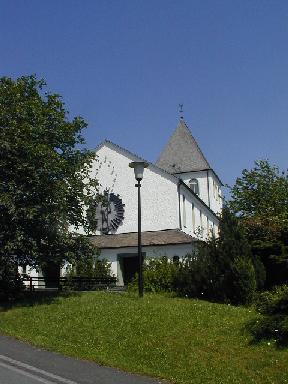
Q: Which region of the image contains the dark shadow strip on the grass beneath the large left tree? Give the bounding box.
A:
[0,291,81,312]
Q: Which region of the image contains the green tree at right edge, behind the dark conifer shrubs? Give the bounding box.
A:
[229,160,288,287]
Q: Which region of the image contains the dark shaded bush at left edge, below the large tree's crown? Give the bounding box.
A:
[0,254,24,302]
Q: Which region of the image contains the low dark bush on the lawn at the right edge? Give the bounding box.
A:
[249,285,288,345]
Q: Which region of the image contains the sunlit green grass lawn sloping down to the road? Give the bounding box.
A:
[0,292,288,384]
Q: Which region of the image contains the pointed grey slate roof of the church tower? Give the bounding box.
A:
[156,119,211,173]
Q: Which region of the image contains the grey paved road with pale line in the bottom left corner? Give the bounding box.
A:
[0,335,163,384]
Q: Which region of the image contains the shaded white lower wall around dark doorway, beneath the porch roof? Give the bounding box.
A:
[100,244,194,285]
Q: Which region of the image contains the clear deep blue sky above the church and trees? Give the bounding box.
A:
[0,0,288,190]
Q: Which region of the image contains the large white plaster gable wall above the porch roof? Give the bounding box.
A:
[91,144,179,233]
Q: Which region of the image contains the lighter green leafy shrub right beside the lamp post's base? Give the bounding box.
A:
[129,256,177,292]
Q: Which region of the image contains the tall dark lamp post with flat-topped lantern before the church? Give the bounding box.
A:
[129,161,148,297]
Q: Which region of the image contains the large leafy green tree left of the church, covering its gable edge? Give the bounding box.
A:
[0,76,97,272]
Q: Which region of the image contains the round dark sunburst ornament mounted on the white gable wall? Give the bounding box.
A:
[95,190,125,234]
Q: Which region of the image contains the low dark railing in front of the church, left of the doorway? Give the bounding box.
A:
[22,276,117,292]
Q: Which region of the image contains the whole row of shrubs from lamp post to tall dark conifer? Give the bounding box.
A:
[130,207,256,304]
